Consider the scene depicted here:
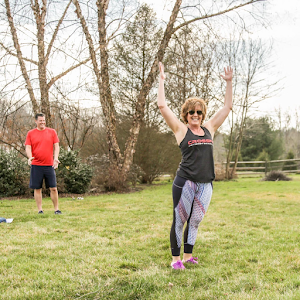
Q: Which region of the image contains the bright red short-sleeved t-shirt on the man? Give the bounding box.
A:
[25,127,59,166]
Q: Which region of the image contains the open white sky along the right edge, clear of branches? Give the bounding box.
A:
[261,0,300,121]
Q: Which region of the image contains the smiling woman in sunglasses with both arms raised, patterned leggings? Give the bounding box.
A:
[157,63,233,269]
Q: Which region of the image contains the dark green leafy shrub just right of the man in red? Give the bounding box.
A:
[57,148,93,194]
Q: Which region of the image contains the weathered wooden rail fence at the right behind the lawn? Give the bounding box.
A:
[223,158,300,175]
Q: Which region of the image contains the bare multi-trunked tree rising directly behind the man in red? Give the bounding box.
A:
[0,0,99,155]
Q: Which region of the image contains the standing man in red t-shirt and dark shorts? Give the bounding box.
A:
[25,113,61,214]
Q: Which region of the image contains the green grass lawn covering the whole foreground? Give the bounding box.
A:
[0,175,300,300]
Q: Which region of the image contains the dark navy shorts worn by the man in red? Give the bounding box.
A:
[29,165,56,190]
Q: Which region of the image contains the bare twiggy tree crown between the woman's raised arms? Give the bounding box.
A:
[165,24,222,117]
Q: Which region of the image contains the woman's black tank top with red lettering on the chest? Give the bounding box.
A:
[177,126,215,183]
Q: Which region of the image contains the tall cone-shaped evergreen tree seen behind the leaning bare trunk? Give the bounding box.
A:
[111,4,162,123]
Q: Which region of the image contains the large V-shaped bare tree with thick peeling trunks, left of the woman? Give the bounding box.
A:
[73,0,261,186]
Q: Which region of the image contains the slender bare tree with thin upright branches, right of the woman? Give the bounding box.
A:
[224,37,278,178]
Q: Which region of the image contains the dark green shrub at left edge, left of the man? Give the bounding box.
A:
[0,150,30,196]
